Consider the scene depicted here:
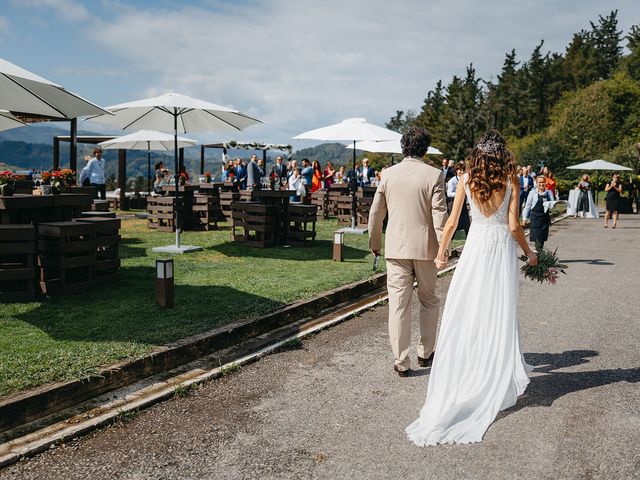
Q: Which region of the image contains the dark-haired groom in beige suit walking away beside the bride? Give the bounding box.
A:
[369,127,448,377]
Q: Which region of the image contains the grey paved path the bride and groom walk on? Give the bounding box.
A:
[0,215,640,480]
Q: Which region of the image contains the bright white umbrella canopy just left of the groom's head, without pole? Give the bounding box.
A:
[293,118,402,142]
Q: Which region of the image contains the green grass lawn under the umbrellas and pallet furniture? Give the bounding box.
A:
[0,219,463,396]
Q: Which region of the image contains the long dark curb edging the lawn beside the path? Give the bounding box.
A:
[0,273,387,433]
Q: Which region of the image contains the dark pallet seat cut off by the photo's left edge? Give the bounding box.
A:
[0,225,36,302]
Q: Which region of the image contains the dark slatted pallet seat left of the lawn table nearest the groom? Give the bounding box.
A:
[231,202,279,248]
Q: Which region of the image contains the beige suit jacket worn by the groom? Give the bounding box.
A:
[369,157,448,260]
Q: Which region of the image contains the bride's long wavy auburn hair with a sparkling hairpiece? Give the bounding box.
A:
[467,130,516,202]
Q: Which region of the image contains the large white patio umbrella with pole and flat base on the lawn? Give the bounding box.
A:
[87,93,262,253]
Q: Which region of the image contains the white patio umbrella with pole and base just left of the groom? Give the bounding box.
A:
[293,118,402,234]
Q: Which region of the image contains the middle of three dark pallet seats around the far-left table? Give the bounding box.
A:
[37,222,97,295]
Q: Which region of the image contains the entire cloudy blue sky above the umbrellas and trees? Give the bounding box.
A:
[0,0,640,148]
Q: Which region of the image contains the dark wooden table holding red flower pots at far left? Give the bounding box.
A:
[0,193,93,225]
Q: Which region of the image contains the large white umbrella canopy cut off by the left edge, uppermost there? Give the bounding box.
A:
[0,58,109,119]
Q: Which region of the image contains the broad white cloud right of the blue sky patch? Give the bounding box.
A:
[86,0,640,142]
